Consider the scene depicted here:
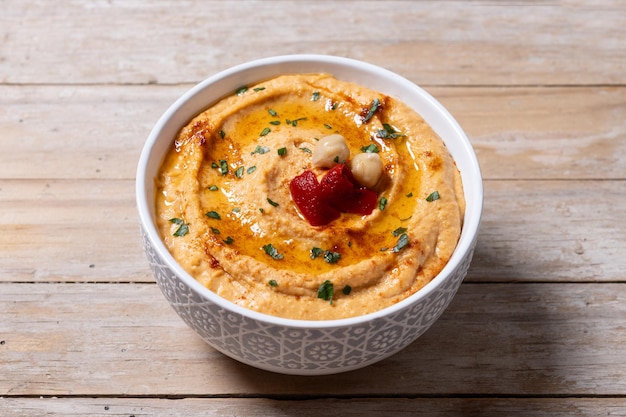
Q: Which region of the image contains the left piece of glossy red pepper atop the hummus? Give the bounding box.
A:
[289,171,341,226]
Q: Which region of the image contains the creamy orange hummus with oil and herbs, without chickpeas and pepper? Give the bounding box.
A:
[156,74,465,320]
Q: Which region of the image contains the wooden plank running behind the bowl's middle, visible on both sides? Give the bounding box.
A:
[0,180,626,282]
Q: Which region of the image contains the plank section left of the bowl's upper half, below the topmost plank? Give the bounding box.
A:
[0,85,190,179]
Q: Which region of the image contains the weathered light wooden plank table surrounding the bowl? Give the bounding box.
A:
[0,0,626,417]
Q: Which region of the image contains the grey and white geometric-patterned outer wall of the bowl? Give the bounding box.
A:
[141,227,475,375]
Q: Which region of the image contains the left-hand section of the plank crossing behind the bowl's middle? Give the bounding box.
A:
[0,180,154,282]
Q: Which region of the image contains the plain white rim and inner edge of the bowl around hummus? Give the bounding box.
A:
[135,54,483,329]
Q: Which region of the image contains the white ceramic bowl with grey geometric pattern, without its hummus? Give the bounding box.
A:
[136,55,483,375]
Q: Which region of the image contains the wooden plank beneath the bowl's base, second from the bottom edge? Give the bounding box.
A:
[0,283,626,394]
